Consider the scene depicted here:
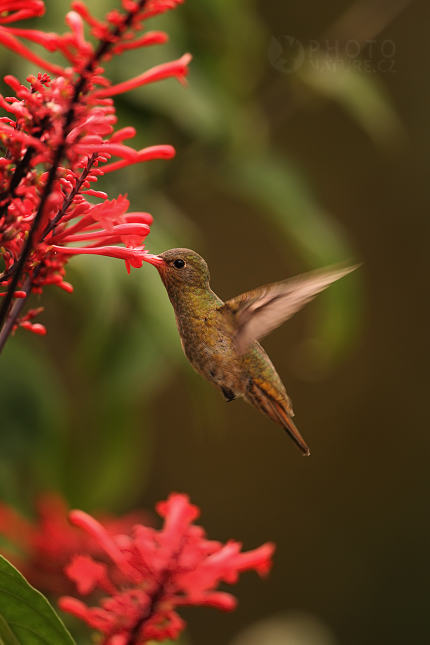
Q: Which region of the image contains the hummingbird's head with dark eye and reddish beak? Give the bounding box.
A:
[145,249,210,293]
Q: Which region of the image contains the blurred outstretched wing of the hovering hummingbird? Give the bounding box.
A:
[221,265,358,354]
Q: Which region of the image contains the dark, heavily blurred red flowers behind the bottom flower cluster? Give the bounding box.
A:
[0,493,153,596]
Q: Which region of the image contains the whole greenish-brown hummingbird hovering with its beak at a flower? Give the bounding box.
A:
[145,248,357,456]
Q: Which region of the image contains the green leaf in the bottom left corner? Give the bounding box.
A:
[0,556,74,645]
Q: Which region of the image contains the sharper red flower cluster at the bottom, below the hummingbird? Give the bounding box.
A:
[59,494,274,645]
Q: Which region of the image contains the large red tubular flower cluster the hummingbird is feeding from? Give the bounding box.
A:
[0,0,191,345]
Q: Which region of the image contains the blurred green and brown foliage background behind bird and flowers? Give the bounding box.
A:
[0,0,430,645]
